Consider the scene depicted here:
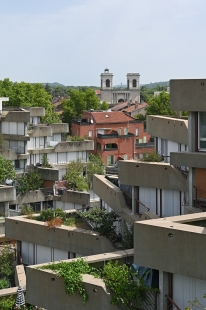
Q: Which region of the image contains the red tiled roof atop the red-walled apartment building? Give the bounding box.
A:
[91,111,134,124]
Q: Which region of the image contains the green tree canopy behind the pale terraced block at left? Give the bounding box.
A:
[0,78,60,124]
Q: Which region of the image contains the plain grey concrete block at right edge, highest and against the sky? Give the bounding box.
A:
[170,79,206,112]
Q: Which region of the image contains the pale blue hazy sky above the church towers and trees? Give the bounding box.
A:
[0,0,206,86]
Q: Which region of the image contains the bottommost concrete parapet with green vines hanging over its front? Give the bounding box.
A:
[26,250,133,310]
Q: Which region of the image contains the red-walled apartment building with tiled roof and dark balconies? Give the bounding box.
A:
[72,111,154,165]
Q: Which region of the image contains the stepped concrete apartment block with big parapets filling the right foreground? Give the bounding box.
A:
[14,80,206,310]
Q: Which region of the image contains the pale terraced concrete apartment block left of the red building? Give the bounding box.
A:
[0,103,94,215]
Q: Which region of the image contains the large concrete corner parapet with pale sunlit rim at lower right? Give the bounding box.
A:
[134,213,206,280]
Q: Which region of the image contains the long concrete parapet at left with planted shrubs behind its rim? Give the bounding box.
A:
[5,216,115,256]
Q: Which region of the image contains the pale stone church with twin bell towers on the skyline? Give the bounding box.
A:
[100,68,140,104]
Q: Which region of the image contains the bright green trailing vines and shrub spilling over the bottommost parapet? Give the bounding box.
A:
[37,259,148,310]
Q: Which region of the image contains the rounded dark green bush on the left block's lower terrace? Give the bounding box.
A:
[16,170,43,194]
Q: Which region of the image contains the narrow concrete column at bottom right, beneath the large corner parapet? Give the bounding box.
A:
[157,270,168,310]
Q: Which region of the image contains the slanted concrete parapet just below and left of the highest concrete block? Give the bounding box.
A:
[147,115,188,145]
